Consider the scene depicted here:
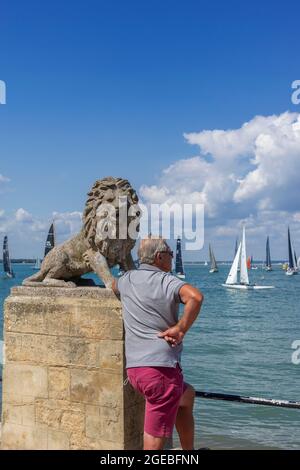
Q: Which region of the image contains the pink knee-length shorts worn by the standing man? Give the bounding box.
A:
[127,364,187,437]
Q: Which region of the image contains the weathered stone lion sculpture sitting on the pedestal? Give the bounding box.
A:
[23,177,141,288]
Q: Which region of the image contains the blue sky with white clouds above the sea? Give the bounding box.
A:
[0,0,300,260]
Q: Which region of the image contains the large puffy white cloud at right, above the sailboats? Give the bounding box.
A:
[140,112,300,217]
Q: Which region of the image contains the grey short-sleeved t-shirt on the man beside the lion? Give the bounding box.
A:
[117,264,186,368]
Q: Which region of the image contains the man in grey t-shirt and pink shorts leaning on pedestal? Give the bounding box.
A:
[113,237,203,450]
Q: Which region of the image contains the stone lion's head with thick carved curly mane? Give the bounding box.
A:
[83,177,141,265]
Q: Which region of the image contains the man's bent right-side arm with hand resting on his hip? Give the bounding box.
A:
[158,284,204,346]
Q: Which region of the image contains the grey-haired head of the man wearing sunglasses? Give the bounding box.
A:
[138,235,173,272]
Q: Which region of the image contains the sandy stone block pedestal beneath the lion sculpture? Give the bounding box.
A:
[2,287,144,450]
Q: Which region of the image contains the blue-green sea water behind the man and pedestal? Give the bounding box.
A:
[0,263,300,449]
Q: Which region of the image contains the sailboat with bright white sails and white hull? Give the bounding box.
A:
[222,227,274,290]
